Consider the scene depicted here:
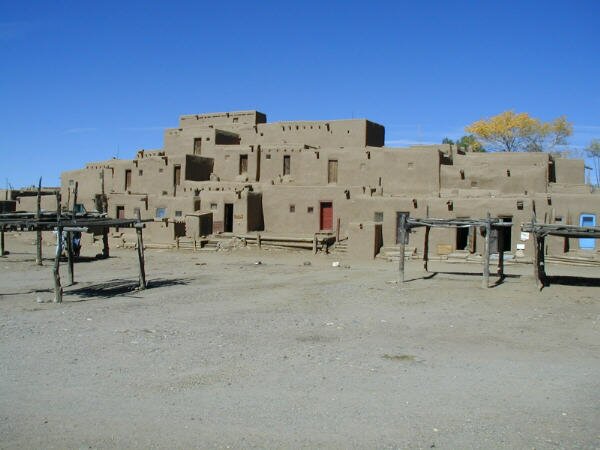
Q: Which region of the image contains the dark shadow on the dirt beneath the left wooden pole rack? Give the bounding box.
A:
[65,278,190,302]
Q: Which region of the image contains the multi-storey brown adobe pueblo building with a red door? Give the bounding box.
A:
[61,111,600,259]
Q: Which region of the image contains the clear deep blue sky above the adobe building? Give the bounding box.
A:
[0,0,600,187]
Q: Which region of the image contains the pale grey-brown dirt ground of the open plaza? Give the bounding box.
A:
[0,238,600,449]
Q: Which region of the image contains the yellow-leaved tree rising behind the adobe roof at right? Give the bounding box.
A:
[465,111,573,152]
